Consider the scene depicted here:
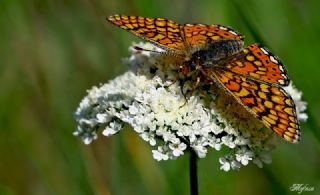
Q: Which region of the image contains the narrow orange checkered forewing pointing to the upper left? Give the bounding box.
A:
[107,15,184,53]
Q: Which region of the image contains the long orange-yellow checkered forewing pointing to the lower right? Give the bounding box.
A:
[206,69,300,143]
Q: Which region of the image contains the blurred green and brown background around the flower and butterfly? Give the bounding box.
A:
[0,0,320,195]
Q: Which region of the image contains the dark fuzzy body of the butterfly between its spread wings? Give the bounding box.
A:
[186,40,243,69]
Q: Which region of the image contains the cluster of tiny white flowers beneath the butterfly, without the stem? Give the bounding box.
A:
[74,44,307,171]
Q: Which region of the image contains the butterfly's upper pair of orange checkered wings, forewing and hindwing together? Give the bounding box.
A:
[107,15,243,55]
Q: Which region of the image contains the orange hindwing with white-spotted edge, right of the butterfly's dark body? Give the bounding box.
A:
[225,44,289,86]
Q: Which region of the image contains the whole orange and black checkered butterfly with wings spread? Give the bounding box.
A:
[107,15,300,143]
